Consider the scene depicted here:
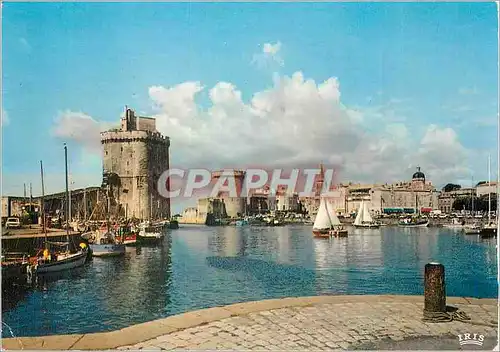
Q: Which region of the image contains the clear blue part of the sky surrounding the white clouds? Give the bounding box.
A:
[2,3,498,212]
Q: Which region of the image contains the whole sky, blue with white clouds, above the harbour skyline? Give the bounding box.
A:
[2,3,498,211]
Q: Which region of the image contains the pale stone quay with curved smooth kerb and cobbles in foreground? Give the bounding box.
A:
[2,295,498,351]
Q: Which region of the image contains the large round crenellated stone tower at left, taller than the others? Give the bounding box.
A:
[101,108,170,219]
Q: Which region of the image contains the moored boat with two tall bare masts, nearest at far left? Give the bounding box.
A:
[32,144,88,274]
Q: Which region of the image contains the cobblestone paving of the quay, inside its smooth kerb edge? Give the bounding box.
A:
[119,301,497,351]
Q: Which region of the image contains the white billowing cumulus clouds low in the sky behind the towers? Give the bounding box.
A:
[55,71,470,185]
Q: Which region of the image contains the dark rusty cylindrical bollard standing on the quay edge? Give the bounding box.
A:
[424,263,446,313]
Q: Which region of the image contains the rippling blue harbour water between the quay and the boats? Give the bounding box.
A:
[2,226,498,337]
